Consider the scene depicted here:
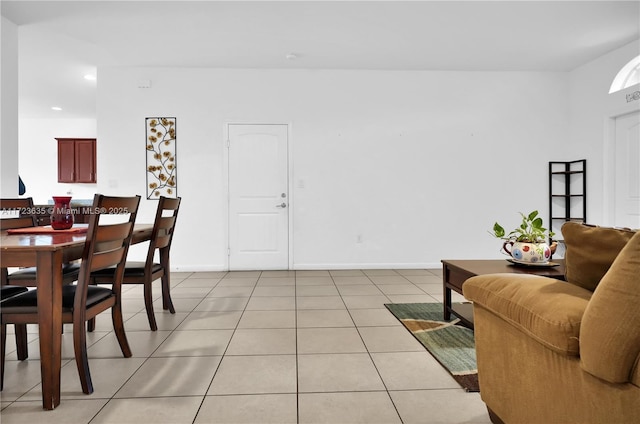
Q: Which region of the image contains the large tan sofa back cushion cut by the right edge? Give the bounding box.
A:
[580,232,640,384]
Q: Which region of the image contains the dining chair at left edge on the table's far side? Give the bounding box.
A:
[0,197,79,287]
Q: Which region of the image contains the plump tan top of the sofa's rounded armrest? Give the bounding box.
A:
[462,274,592,356]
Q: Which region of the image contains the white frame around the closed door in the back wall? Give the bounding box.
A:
[222,121,294,271]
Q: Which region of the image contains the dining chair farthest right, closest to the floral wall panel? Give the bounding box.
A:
[89,196,181,331]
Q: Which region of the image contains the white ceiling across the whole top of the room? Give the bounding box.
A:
[0,0,640,118]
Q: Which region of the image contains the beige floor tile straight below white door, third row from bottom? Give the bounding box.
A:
[226,328,296,355]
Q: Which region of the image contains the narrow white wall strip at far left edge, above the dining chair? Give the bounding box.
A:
[0,17,18,197]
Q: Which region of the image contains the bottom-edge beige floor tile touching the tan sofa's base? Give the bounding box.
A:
[390,388,491,424]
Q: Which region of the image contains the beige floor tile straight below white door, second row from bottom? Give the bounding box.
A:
[207,355,296,395]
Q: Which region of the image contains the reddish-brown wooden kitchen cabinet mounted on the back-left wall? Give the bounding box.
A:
[56,138,96,183]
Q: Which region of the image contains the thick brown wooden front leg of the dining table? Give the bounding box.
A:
[36,251,62,409]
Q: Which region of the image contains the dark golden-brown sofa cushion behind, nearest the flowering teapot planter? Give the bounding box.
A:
[562,222,635,291]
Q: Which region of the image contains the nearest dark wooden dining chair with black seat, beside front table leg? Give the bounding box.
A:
[0,194,140,394]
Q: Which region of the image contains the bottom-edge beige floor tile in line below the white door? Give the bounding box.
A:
[194,394,298,424]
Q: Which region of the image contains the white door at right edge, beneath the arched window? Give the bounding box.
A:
[614,112,640,228]
